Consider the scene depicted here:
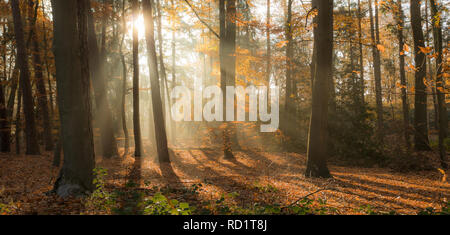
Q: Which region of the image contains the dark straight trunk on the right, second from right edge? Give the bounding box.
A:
[410,0,430,151]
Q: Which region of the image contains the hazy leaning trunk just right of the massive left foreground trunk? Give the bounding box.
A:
[88,1,118,158]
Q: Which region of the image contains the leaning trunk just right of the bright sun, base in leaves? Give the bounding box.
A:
[143,0,170,163]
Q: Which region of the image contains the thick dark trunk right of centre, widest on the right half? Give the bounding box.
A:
[305,0,333,178]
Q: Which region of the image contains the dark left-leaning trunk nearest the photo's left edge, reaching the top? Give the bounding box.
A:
[11,0,39,155]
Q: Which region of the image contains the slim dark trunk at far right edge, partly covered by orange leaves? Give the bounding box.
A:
[430,0,448,169]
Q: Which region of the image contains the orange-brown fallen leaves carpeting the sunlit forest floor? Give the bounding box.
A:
[0,149,450,214]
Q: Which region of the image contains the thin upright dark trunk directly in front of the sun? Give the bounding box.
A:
[131,0,142,157]
